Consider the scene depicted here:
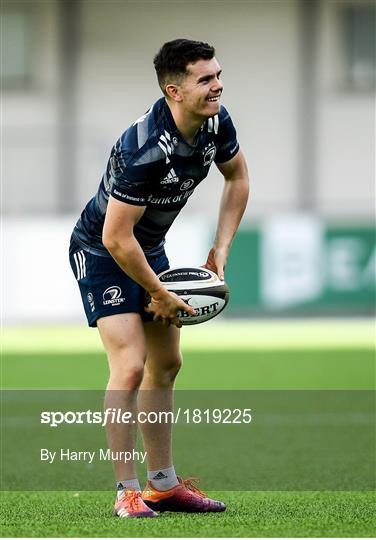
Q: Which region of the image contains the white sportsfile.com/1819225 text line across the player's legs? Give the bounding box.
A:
[40,407,252,427]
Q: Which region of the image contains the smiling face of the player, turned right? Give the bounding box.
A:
[169,58,223,119]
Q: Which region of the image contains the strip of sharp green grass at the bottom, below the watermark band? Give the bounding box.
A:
[2,491,376,538]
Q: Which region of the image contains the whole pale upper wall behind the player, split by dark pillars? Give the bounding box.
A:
[2,0,374,220]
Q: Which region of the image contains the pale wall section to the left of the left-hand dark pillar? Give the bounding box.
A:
[1,0,59,216]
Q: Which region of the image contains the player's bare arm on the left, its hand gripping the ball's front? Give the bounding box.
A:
[102,196,195,326]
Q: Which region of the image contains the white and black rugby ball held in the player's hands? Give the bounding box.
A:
[158,267,230,325]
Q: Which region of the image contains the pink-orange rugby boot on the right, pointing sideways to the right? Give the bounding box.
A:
[142,476,226,512]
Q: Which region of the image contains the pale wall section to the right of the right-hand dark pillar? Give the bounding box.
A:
[317,0,375,220]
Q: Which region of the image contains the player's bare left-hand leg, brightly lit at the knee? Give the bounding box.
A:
[97,313,146,480]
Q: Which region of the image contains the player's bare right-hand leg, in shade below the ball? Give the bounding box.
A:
[138,322,182,471]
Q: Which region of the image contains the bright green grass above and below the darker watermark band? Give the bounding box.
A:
[0,321,376,537]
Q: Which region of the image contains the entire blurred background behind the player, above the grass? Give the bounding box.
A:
[1,0,376,324]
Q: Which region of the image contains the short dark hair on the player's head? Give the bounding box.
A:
[154,38,215,95]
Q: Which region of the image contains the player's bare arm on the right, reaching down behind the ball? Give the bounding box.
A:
[204,150,249,279]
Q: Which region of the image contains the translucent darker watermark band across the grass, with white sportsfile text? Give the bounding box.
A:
[0,390,376,491]
